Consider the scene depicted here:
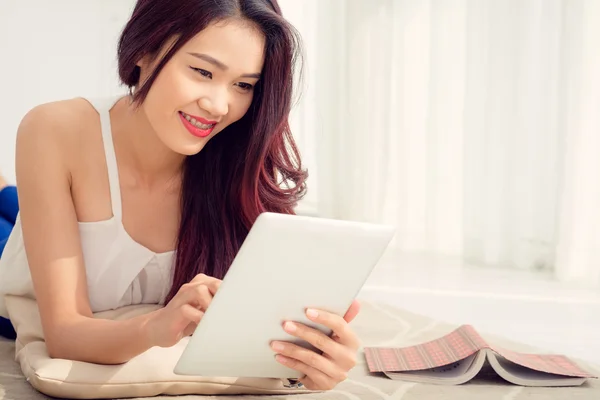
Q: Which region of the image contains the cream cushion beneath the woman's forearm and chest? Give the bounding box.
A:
[6,296,308,399]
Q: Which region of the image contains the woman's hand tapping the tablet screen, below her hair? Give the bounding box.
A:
[146,274,221,347]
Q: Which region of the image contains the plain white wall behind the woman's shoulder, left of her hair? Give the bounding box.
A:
[0,0,134,180]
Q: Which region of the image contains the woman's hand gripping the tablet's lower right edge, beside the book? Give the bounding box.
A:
[271,301,360,390]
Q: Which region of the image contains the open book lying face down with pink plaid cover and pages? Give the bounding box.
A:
[365,325,597,386]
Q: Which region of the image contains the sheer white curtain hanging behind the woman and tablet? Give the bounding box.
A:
[281,0,600,286]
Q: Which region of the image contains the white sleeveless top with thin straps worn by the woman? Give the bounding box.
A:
[0,97,175,318]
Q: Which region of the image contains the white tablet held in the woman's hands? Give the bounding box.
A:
[174,213,395,379]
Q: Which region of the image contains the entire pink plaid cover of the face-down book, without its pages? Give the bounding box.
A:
[365,325,594,378]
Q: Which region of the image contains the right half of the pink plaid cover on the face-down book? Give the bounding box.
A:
[491,347,597,378]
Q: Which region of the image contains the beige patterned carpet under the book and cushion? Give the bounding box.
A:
[0,302,600,400]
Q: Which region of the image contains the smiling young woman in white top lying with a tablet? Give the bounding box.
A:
[0,0,359,390]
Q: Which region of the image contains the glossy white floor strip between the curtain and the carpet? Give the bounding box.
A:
[362,252,600,365]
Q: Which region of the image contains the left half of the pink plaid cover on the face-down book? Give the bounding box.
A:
[364,325,490,372]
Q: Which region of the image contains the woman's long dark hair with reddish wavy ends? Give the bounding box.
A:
[118,0,307,302]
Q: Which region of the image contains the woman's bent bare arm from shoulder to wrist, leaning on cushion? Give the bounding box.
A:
[16,104,159,364]
